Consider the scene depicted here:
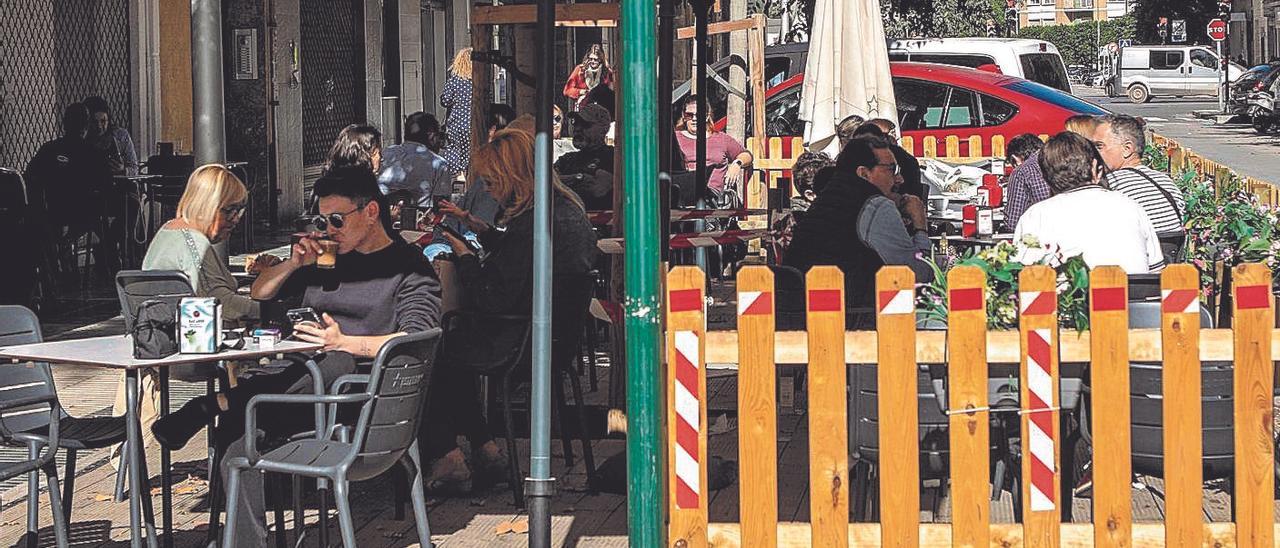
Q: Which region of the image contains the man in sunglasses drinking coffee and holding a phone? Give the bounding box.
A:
[152,168,440,545]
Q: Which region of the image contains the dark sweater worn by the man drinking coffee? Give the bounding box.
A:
[280,239,440,335]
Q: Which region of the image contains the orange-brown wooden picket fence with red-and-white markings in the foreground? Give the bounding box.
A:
[666,264,1280,548]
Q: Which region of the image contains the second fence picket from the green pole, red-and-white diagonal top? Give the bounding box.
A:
[737,266,778,548]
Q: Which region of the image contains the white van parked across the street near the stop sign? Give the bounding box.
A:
[1107,45,1244,102]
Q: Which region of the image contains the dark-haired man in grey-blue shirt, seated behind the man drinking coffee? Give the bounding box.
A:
[378,113,453,207]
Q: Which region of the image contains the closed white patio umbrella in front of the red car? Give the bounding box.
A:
[800,0,897,157]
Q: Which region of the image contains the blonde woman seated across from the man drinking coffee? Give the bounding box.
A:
[114,164,280,444]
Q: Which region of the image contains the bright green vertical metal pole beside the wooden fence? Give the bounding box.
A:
[620,0,671,548]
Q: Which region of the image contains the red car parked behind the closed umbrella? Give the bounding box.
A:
[727,61,1108,156]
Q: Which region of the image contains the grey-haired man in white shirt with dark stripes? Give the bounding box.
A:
[1093,114,1187,239]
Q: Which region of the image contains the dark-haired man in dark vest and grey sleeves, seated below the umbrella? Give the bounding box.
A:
[785,136,933,321]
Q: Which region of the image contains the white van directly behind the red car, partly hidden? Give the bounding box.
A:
[888,38,1071,93]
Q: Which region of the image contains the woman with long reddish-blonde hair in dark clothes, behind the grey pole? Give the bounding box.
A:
[420,129,596,493]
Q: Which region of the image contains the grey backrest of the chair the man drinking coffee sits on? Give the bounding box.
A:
[344,329,440,481]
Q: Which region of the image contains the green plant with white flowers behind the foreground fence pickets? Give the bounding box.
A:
[916,239,1089,330]
